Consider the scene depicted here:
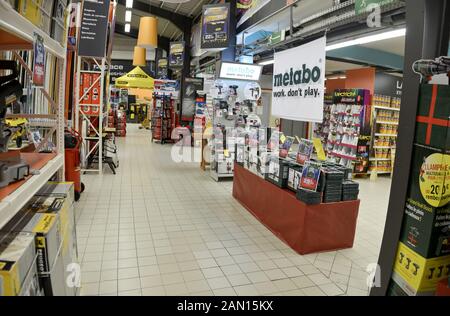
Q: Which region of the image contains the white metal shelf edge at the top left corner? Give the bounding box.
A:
[0,0,66,59]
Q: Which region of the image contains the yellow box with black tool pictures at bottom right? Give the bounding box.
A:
[392,242,450,296]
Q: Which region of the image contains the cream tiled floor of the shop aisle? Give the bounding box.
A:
[76,126,390,296]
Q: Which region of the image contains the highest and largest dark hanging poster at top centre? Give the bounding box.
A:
[201,3,230,49]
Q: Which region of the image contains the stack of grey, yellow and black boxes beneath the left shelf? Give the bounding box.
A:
[0,183,78,296]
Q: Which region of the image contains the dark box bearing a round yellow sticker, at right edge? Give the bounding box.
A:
[400,145,450,258]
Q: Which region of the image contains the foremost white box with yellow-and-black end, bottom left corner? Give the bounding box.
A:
[0,232,40,296]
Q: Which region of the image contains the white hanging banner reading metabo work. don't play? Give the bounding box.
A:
[272,37,327,123]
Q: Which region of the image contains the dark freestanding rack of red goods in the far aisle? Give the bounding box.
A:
[151,92,175,144]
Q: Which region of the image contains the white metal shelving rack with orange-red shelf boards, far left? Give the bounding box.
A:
[0,0,66,228]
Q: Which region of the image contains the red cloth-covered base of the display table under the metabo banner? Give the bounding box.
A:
[233,164,360,255]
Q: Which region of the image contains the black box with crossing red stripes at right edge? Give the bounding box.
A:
[415,84,450,149]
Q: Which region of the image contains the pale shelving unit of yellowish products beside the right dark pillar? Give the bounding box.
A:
[369,95,400,175]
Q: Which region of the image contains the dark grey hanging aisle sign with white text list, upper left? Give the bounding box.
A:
[78,0,110,58]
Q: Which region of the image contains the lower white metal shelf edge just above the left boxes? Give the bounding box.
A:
[0,154,64,228]
